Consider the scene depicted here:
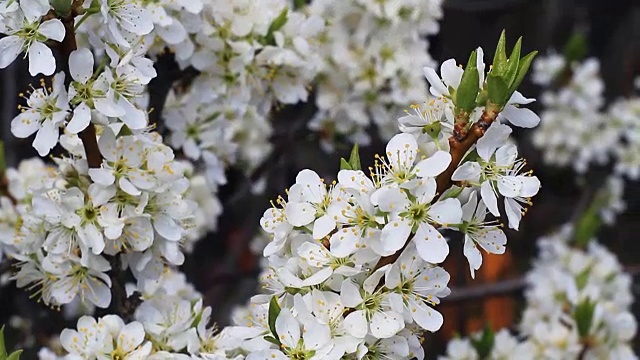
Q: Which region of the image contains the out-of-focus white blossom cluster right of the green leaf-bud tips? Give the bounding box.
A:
[533,54,640,179]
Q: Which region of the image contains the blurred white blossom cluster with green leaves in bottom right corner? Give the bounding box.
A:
[441,225,637,360]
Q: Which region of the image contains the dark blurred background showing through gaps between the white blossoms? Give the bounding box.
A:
[0,0,640,358]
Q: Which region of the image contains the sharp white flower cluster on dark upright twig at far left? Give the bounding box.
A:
[0,0,220,308]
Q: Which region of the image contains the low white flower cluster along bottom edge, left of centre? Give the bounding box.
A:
[39,270,238,360]
